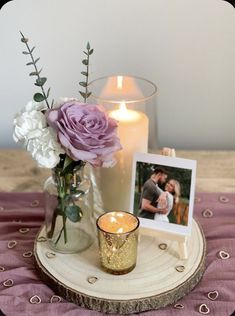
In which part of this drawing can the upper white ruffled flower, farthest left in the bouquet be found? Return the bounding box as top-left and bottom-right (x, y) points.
(13, 101), (47, 146)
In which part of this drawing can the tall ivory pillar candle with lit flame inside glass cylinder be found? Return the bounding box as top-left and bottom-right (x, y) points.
(95, 102), (148, 211)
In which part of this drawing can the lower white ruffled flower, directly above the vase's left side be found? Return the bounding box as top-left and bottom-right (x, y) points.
(27, 127), (64, 168)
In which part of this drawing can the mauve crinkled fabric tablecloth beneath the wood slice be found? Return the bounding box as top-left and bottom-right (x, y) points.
(0, 193), (235, 316)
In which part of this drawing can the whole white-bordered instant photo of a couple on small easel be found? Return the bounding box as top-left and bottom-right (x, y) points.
(130, 153), (196, 235)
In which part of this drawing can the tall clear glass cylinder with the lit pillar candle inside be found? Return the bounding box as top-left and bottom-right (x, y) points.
(89, 75), (157, 213)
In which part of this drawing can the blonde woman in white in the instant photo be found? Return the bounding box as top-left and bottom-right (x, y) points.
(154, 179), (180, 223)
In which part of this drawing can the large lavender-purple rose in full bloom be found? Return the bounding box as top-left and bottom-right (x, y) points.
(47, 100), (121, 166)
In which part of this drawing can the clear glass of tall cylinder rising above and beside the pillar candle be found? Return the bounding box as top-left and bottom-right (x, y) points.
(89, 75), (157, 148)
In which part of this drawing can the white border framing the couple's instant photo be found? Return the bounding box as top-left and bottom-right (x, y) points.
(130, 153), (197, 236)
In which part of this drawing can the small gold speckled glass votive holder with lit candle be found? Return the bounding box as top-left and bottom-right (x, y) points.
(96, 211), (140, 274)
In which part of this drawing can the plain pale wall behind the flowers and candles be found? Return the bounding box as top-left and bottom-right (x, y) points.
(0, 0), (235, 149)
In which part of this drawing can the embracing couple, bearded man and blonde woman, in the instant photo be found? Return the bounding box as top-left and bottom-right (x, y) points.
(139, 168), (180, 222)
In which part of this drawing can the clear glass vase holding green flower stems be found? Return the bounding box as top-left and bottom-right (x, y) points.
(44, 162), (95, 253)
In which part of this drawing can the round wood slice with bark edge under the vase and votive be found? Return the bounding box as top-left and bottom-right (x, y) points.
(34, 220), (206, 314)
